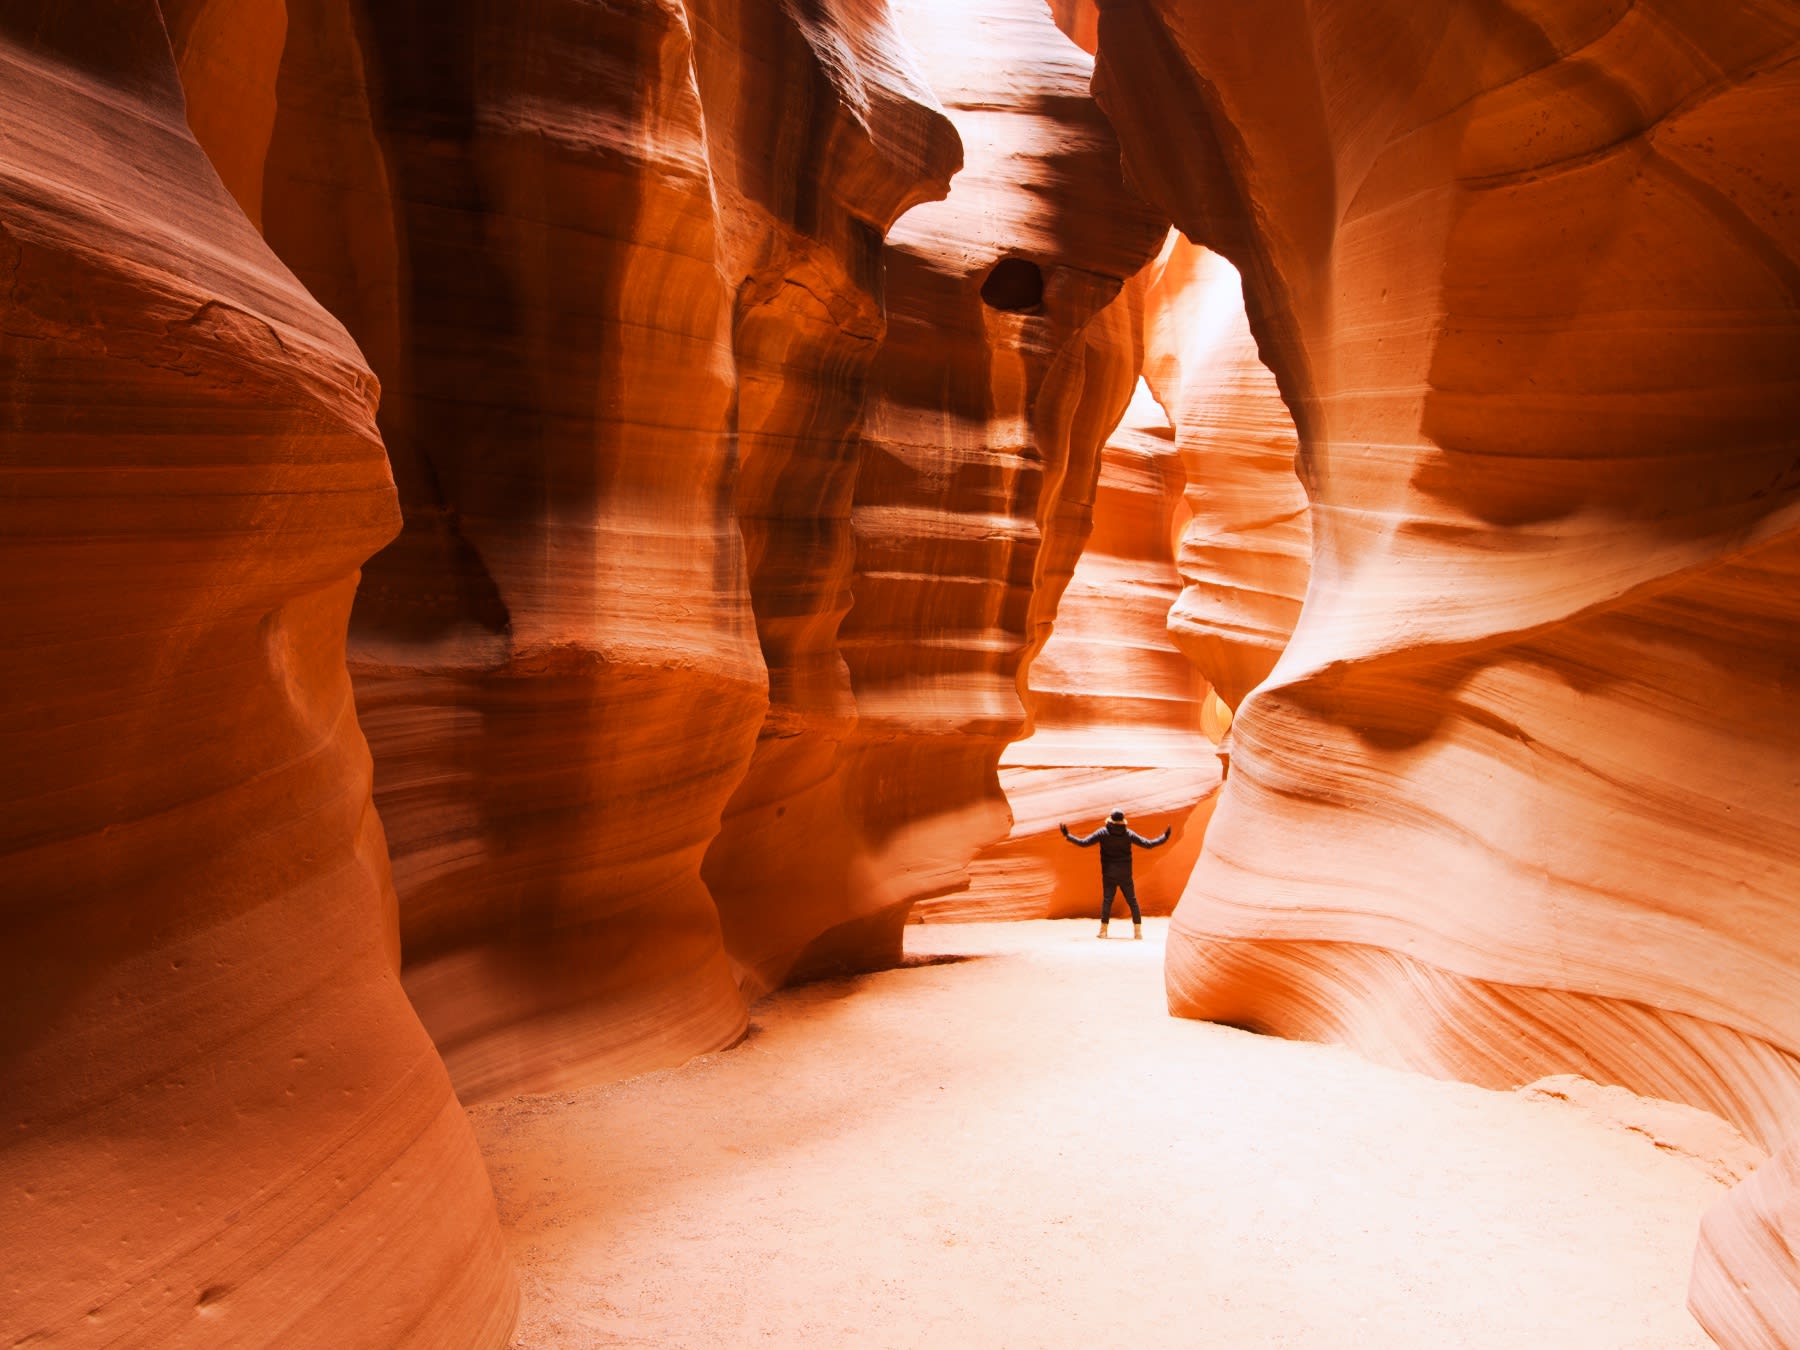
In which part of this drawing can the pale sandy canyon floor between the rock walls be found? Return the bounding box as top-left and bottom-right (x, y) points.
(472, 920), (1749, 1350)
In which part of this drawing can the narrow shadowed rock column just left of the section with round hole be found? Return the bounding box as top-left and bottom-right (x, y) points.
(698, 5), (961, 997)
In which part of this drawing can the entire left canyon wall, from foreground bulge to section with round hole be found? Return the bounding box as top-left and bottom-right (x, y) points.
(0, 10), (1166, 1345)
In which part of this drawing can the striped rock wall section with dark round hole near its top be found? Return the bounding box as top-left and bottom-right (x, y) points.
(814, 0), (1166, 963)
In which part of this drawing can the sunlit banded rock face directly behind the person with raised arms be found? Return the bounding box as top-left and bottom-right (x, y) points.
(914, 382), (1219, 922)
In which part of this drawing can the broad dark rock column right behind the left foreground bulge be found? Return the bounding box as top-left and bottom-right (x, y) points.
(265, 0), (767, 1100)
